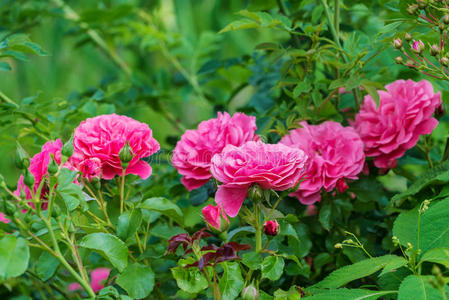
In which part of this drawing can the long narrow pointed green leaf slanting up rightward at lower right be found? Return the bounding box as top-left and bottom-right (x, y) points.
(313, 255), (404, 288)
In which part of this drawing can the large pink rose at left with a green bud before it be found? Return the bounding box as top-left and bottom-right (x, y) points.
(72, 114), (159, 179)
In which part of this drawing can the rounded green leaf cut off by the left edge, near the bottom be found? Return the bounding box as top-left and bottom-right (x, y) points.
(0, 235), (30, 280)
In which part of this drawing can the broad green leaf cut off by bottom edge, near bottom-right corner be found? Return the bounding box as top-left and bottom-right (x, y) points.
(398, 275), (448, 300)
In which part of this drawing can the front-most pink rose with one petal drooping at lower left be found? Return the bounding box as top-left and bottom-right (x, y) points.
(211, 141), (307, 217)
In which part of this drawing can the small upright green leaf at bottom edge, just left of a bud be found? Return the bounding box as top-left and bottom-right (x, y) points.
(218, 262), (244, 300)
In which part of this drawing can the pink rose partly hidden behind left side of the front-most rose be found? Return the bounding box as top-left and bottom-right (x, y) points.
(172, 112), (258, 191)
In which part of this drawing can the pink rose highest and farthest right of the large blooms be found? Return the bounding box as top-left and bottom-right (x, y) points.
(352, 80), (441, 169)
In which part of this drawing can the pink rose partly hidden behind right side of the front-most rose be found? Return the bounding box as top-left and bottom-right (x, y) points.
(280, 121), (365, 205)
